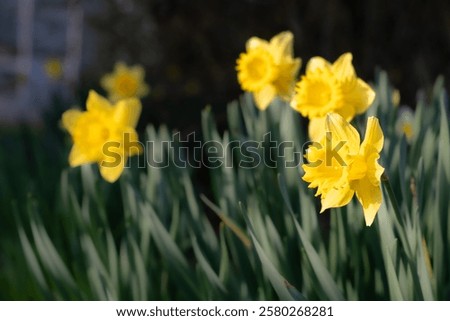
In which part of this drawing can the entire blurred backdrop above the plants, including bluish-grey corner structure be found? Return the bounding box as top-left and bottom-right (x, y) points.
(0, 0), (450, 131)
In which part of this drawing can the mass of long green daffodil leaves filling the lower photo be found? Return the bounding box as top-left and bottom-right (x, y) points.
(0, 73), (450, 300)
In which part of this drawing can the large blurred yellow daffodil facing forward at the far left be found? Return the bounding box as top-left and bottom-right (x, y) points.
(62, 90), (142, 183)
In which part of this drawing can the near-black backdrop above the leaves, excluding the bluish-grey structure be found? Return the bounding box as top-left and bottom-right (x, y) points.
(80, 0), (450, 131)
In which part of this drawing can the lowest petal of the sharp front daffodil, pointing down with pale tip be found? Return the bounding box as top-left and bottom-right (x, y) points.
(353, 179), (382, 226)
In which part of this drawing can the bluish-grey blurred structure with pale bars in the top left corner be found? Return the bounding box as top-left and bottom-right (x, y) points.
(0, 0), (90, 123)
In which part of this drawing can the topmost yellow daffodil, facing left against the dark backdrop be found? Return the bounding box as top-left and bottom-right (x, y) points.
(236, 31), (301, 110)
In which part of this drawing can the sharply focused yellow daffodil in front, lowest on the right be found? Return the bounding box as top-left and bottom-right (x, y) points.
(302, 113), (384, 226)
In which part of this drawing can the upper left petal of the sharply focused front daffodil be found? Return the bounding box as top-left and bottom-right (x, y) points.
(326, 113), (360, 154)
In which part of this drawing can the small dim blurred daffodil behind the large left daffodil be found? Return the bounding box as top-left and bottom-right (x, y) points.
(100, 62), (149, 102)
